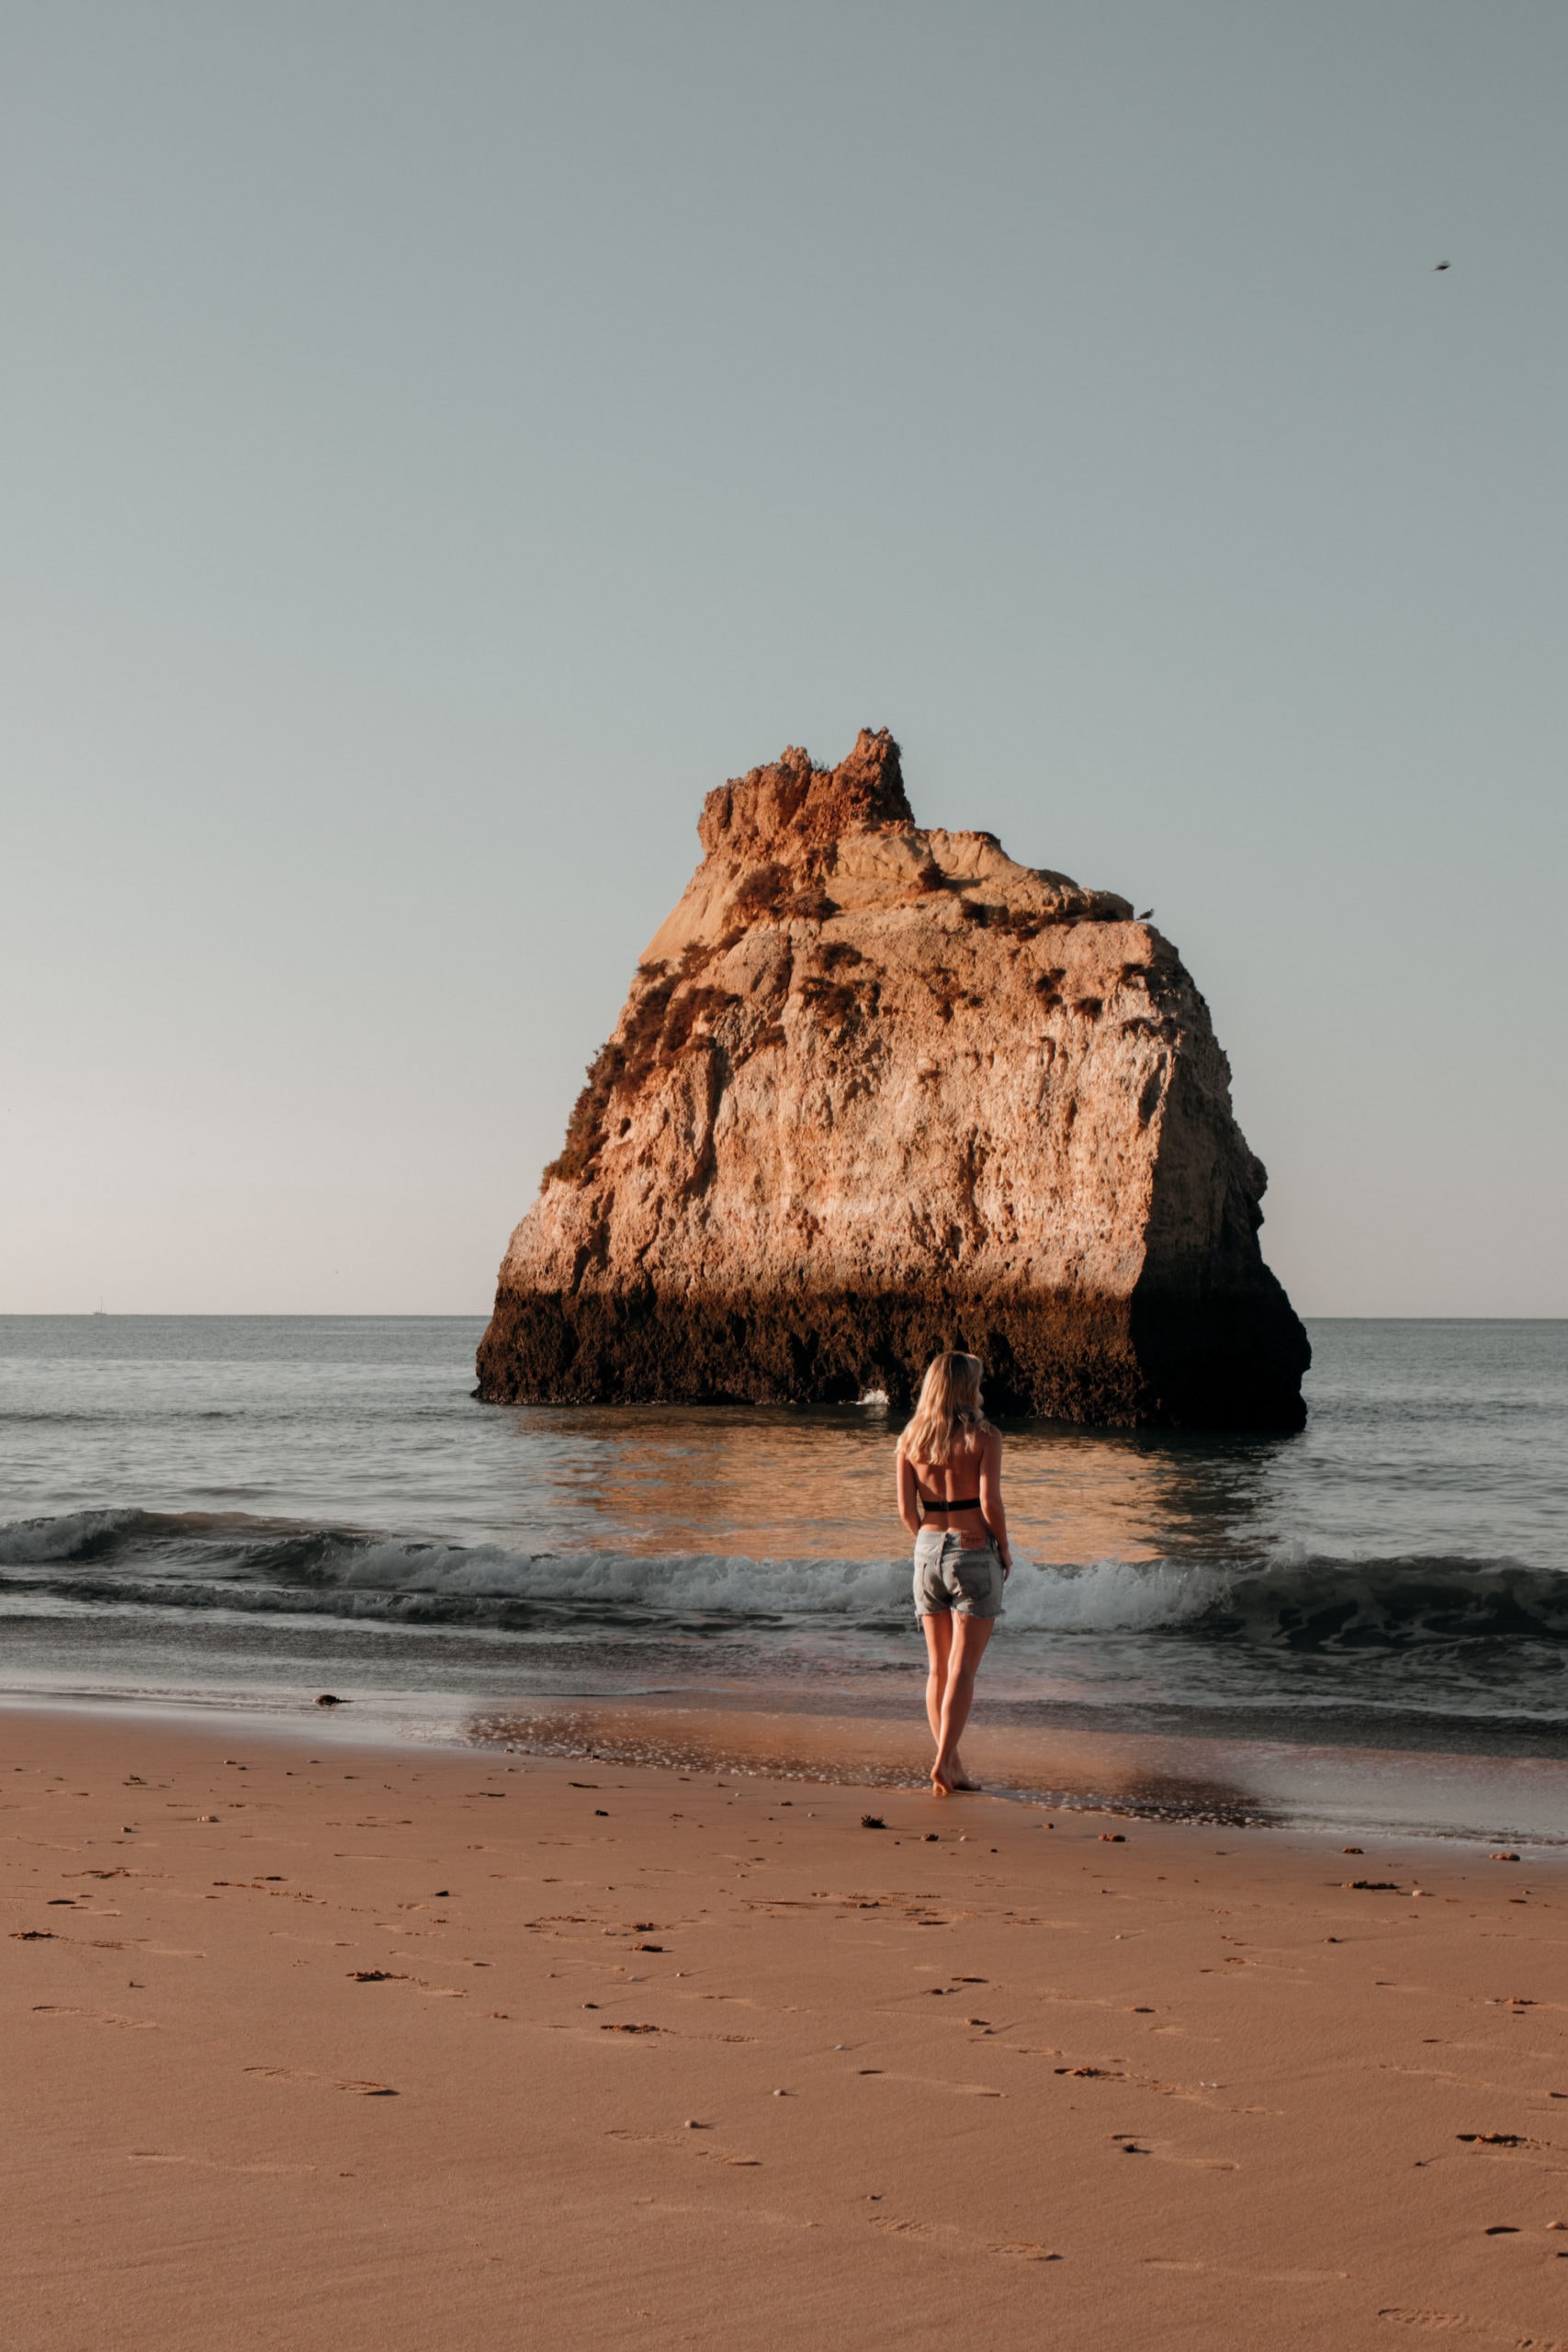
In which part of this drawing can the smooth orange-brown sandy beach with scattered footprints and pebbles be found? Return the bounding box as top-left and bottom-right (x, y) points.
(0, 1713), (1568, 2352)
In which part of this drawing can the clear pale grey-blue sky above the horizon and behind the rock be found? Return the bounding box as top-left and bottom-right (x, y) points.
(0, 0), (1568, 1315)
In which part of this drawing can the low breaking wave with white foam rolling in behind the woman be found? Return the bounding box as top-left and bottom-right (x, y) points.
(0, 1510), (1568, 1651)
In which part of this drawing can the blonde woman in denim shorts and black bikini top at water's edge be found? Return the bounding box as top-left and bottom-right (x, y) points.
(898, 1352), (1013, 1797)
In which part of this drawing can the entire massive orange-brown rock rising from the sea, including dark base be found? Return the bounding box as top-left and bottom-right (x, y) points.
(479, 731), (1309, 1428)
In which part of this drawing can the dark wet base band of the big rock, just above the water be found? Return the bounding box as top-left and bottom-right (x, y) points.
(478, 1268), (1312, 1430)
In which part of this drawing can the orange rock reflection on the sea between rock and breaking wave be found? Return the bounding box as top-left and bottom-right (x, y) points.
(514, 1407), (1291, 1564)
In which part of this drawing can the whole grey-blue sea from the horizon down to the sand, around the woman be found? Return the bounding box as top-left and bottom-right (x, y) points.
(0, 1315), (1568, 1849)
